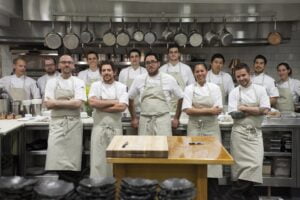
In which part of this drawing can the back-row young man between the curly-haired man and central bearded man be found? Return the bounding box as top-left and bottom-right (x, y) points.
(119, 49), (147, 112)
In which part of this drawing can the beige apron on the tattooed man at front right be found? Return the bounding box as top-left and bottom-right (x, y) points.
(230, 85), (264, 183)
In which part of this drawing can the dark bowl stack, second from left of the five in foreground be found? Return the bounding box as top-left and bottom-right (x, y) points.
(34, 180), (78, 200)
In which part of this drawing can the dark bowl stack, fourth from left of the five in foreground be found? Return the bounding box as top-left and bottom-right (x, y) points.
(120, 178), (158, 200)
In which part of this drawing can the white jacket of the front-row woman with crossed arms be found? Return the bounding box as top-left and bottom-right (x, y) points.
(182, 82), (223, 110)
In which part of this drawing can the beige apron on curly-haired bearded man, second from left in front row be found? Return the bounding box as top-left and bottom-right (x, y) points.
(90, 82), (123, 178)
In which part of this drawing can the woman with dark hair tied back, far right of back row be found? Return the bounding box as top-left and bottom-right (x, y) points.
(276, 63), (300, 112)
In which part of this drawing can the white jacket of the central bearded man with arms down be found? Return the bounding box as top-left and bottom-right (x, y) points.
(128, 72), (183, 102)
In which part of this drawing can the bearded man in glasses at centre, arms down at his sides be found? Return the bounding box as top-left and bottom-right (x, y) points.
(128, 53), (183, 136)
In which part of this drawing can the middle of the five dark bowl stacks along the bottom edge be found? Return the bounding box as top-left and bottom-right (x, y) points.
(76, 177), (116, 200)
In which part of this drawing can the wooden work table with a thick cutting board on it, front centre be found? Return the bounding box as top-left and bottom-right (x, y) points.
(107, 136), (234, 200)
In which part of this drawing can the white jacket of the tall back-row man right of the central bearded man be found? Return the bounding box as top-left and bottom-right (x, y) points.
(159, 62), (195, 86)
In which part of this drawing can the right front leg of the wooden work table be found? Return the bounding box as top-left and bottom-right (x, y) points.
(196, 165), (207, 200)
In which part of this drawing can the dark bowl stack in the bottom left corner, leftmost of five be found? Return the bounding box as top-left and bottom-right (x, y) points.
(0, 176), (37, 200)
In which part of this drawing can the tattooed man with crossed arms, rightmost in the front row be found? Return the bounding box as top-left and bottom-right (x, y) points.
(225, 63), (270, 200)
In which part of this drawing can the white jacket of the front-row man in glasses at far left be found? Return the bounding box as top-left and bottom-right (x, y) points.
(45, 76), (87, 101)
